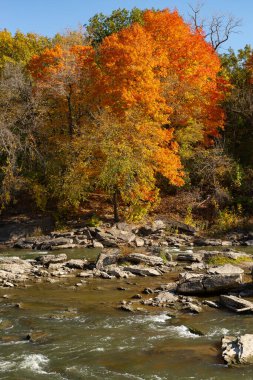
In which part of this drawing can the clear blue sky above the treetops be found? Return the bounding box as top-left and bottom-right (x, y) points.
(0, 0), (253, 50)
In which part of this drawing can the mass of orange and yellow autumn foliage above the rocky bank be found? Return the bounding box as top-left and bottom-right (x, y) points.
(0, 9), (226, 220)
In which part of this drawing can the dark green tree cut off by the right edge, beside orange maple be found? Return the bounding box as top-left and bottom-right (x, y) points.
(222, 46), (253, 166)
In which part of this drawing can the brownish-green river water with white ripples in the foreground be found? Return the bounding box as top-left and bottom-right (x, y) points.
(0, 246), (253, 380)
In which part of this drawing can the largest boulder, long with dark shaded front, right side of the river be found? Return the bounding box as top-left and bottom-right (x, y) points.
(177, 273), (242, 294)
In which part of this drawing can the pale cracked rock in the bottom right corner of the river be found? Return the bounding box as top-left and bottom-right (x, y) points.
(222, 334), (253, 365)
